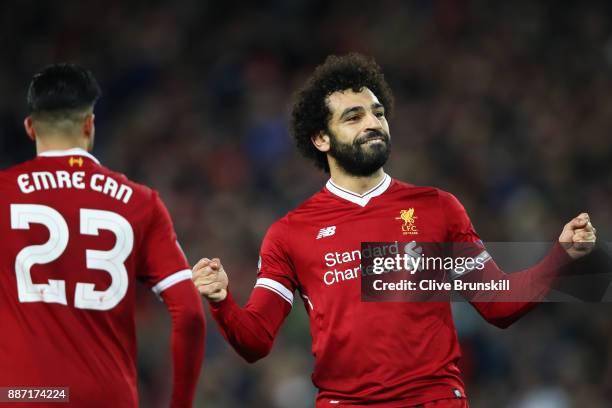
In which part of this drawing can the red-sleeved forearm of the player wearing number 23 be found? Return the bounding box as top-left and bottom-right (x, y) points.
(162, 282), (205, 408)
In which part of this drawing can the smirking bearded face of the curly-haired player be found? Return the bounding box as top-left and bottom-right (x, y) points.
(327, 88), (391, 176)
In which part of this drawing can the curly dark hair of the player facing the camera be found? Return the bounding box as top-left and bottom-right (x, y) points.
(291, 53), (393, 173)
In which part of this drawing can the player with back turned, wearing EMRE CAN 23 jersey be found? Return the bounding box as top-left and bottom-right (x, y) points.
(0, 64), (205, 408)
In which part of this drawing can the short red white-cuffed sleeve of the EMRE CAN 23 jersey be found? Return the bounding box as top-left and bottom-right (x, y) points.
(138, 192), (191, 295)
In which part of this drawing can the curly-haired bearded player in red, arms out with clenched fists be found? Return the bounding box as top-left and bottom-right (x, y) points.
(193, 54), (595, 408)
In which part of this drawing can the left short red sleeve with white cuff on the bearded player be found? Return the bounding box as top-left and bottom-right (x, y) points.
(255, 218), (297, 304)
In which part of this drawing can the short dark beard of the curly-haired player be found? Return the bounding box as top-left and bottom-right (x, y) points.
(328, 130), (391, 177)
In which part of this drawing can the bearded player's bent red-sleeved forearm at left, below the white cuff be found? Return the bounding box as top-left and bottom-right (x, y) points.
(210, 288), (291, 363)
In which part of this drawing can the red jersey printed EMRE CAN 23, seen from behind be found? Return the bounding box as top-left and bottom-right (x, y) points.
(0, 149), (191, 408)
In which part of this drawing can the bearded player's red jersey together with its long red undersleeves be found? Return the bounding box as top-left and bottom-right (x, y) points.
(210, 175), (571, 408)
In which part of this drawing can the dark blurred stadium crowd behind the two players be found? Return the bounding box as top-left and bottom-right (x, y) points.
(0, 0), (612, 408)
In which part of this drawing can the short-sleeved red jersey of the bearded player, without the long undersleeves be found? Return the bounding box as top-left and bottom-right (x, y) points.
(256, 175), (479, 407)
